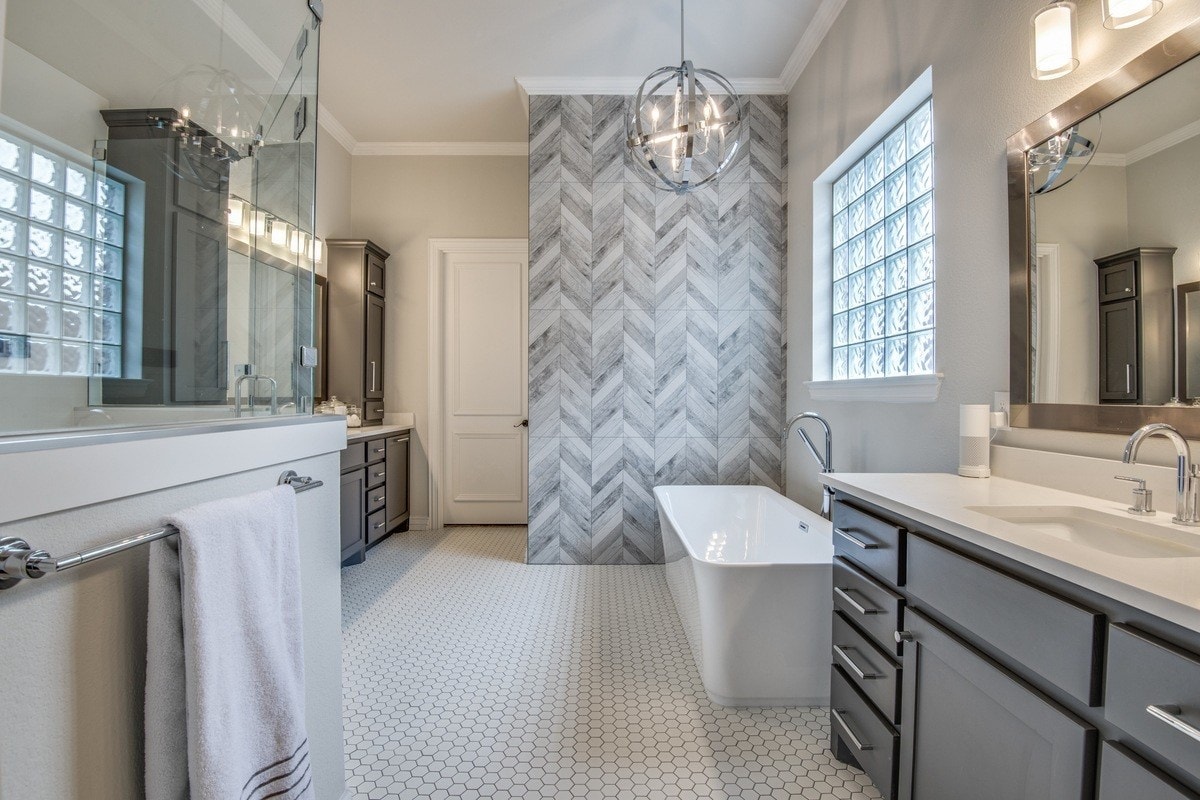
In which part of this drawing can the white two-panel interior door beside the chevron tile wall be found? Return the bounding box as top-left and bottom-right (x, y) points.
(442, 248), (529, 525)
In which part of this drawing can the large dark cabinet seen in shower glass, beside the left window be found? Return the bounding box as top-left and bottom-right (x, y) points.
(101, 108), (229, 405)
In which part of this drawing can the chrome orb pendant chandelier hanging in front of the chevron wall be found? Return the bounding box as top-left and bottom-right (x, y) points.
(626, 0), (744, 194)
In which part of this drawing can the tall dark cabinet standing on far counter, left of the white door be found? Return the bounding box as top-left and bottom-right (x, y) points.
(323, 239), (388, 425)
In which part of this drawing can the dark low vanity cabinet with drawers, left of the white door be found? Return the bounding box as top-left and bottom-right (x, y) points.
(342, 431), (410, 566)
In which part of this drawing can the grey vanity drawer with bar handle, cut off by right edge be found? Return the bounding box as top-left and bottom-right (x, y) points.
(1104, 625), (1200, 778)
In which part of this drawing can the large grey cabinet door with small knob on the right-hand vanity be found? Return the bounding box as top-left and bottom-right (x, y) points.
(899, 610), (1097, 800)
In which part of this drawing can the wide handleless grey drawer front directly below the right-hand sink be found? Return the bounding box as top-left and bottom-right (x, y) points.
(908, 535), (1099, 705)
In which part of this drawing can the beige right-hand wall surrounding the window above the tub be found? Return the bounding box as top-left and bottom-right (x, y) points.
(787, 0), (1200, 513)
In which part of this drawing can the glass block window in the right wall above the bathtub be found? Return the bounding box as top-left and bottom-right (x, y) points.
(833, 100), (934, 380)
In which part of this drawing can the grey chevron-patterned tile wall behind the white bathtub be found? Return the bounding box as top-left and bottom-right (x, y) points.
(528, 95), (787, 564)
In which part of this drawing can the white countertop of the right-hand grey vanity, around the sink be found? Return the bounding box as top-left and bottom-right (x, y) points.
(821, 473), (1200, 632)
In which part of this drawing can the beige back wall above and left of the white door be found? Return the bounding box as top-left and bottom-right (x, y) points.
(350, 156), (529, 518)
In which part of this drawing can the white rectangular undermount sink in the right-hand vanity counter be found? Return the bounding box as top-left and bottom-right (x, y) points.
(967, 505), (1200, 559)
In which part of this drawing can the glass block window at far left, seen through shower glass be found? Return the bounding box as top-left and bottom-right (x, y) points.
(0, 130), (125, 378)
